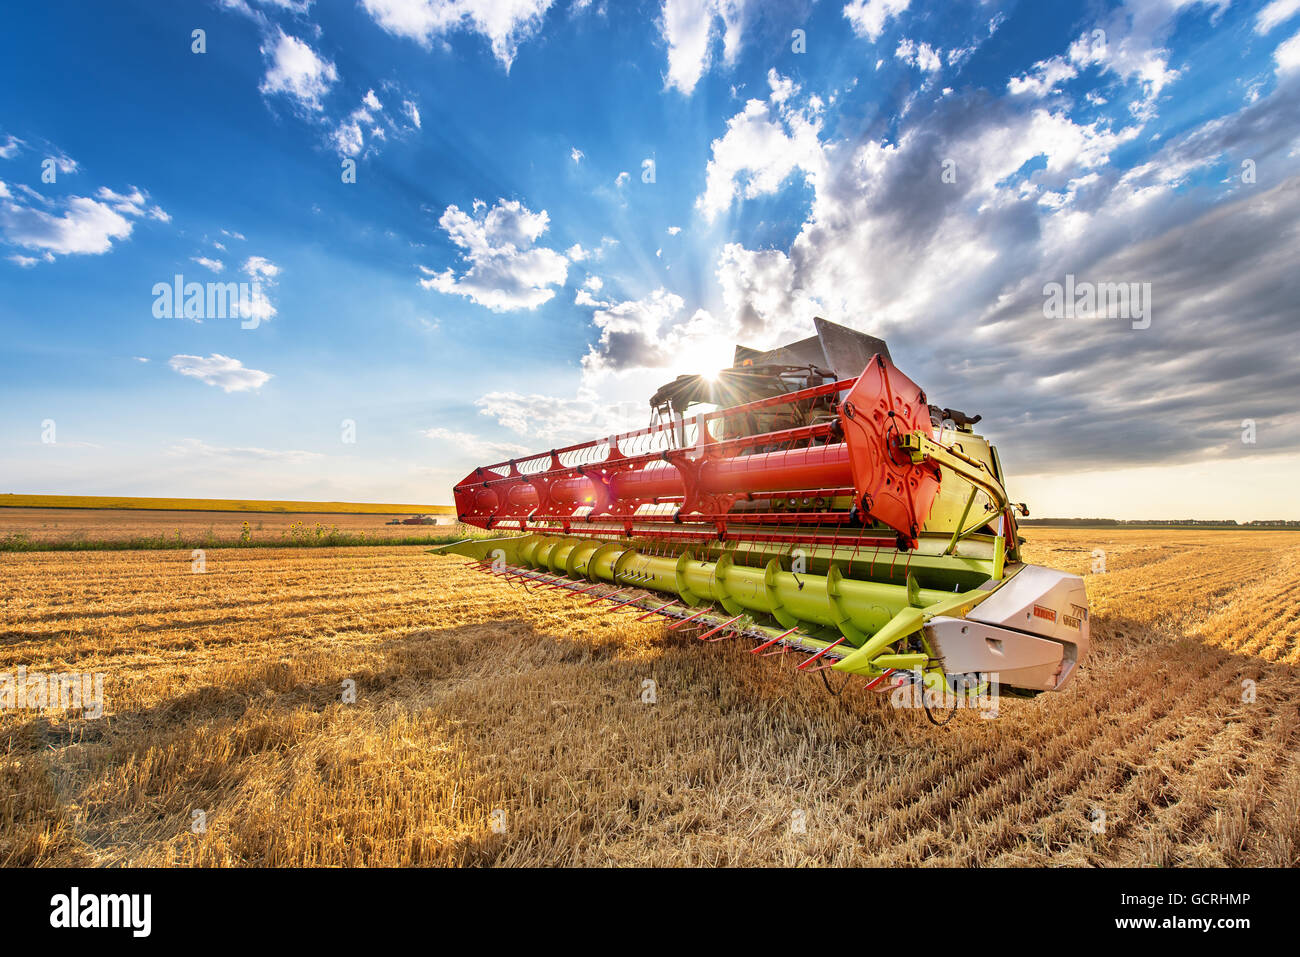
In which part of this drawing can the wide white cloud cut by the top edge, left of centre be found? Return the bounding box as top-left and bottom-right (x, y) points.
(361, 0), (553, 70)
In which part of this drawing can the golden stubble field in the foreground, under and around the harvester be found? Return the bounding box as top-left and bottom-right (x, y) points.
(0, 528), (1300, 866)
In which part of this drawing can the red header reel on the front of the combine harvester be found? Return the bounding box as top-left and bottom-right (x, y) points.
(455, 355), (939, 545)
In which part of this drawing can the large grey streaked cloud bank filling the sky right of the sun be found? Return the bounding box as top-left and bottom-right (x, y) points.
(720, 66), (1300, 473)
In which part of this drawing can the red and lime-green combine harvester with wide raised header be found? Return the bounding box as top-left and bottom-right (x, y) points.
(438, 319), (1088, 720)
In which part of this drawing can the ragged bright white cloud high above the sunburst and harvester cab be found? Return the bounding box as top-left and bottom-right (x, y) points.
(696, 70), (826, 221)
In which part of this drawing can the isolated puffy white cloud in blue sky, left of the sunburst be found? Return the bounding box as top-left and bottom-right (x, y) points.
(420, 199), (568, 312)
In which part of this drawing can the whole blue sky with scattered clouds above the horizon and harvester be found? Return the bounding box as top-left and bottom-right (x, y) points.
(0, 0), (1300, 519)
